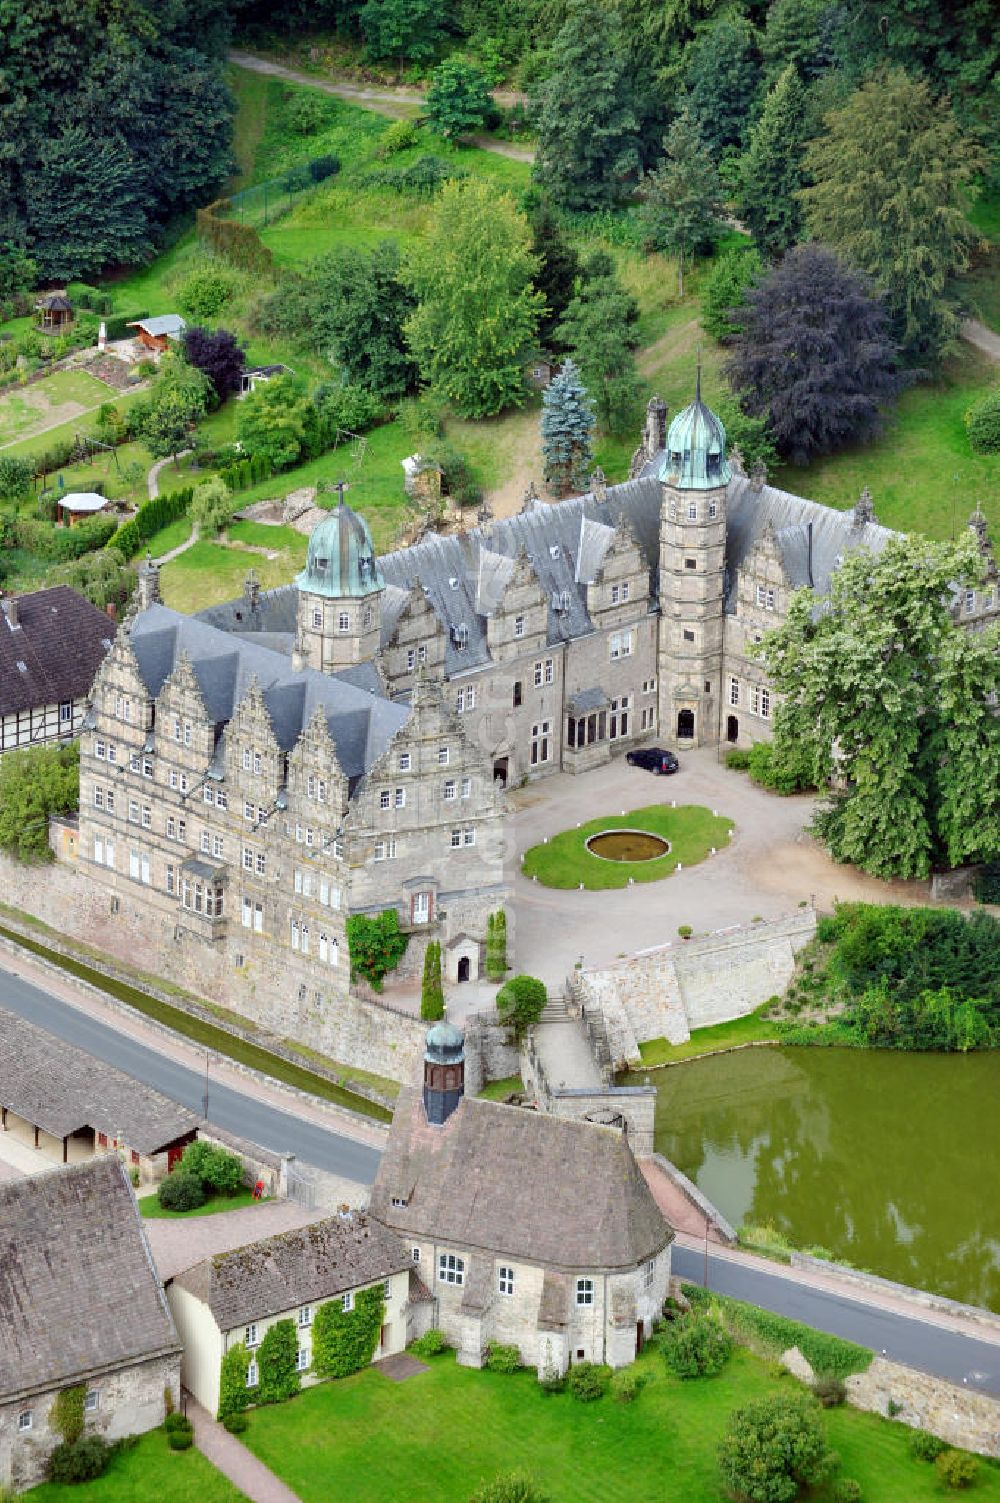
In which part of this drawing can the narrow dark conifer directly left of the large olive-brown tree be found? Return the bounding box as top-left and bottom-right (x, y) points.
(738, 63), (806, 260)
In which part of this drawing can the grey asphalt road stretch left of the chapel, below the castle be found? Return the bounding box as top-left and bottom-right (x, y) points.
(0, 966), (380, 1184)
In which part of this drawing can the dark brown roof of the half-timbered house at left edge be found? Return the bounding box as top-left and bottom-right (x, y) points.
(0, 585), (114, 715)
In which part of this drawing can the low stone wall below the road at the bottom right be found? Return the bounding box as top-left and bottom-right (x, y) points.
(847, 1357), (1000, 1456)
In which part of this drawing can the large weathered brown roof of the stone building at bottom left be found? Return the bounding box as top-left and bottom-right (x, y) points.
(0, 1157), (180, 1404)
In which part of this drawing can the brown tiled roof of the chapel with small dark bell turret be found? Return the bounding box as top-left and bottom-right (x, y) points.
(370, 1087), (674, 1270)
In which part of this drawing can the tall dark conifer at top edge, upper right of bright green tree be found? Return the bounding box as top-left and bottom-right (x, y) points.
(534, 0), (639, 210)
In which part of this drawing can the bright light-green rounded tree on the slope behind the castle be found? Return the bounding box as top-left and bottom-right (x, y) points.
(405, 179), (543, 418)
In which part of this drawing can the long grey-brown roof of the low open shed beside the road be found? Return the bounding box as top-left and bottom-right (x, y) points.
(0, 1007), (198, 1153)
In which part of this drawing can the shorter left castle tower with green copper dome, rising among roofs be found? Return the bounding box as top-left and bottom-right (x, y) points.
(295, 494), (385, 673)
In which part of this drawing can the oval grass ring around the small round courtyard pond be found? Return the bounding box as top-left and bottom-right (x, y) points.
(522, 804), (732, 891)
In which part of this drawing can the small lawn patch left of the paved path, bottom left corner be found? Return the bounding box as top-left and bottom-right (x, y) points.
(24, 1429), (248, 1503)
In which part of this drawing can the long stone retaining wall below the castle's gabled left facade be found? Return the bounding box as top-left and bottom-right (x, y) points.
(0, 855), (426, 1084)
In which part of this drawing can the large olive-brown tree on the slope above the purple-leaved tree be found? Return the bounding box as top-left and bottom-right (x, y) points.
(802, 69), (983, 364)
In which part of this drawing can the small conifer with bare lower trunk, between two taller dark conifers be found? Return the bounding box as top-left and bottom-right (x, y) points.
(641, 110), (723, 298)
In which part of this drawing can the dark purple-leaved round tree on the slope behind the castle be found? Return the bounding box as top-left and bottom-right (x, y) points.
(725, 245), (901, 464)
